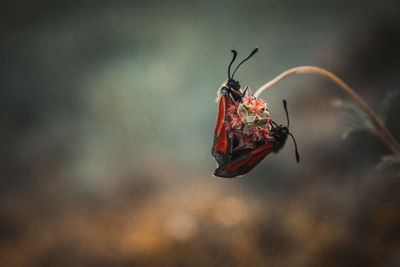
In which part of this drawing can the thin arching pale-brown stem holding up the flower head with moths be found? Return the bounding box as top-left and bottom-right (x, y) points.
(254, 66), (400, 161)
